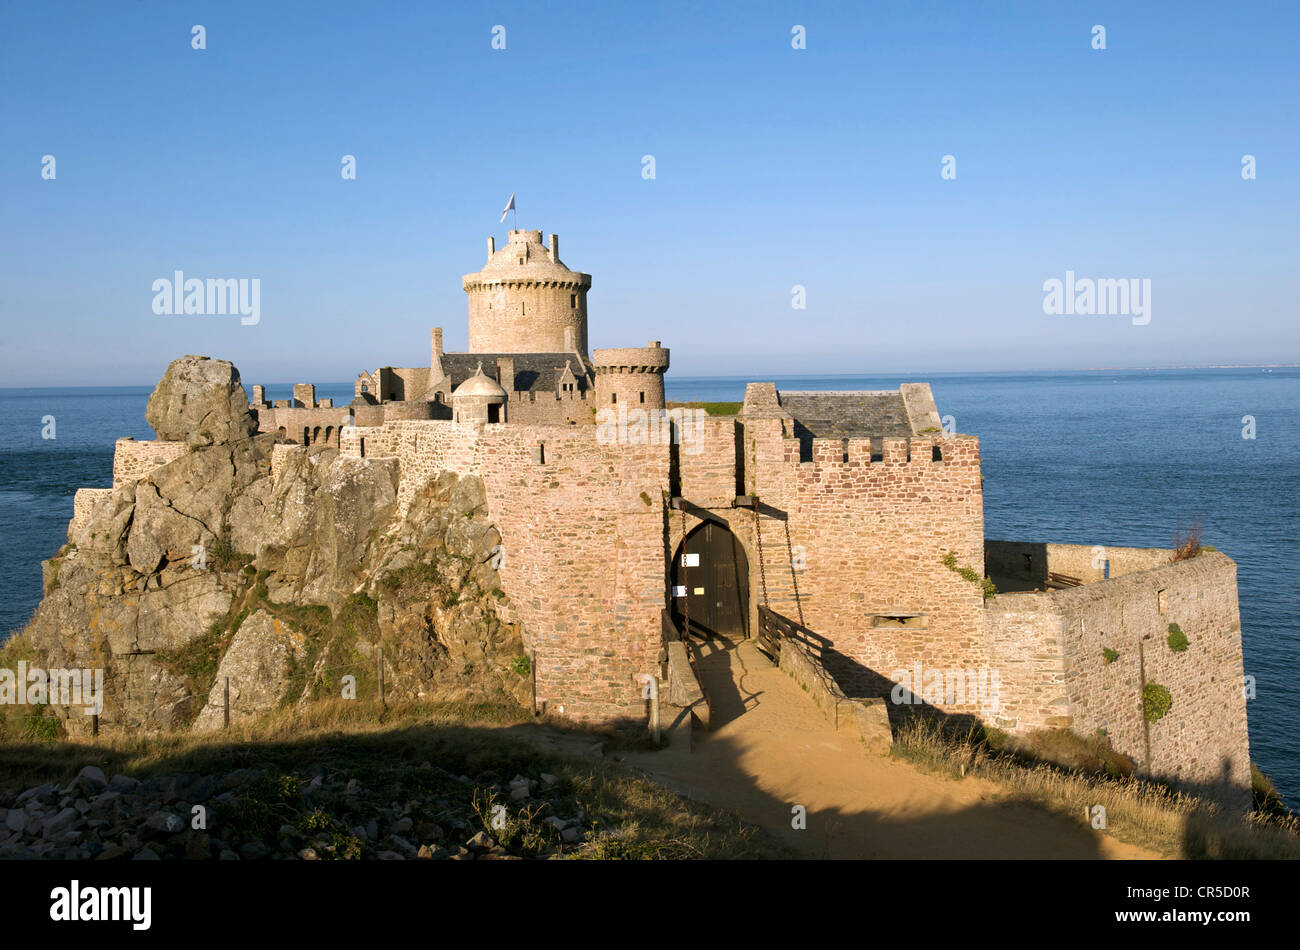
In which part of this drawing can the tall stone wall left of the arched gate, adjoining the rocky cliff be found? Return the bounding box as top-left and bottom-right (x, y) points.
(341, 421), (670, 719)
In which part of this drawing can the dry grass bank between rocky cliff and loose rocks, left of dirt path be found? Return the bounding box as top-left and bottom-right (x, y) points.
(0, 699), (788, 859)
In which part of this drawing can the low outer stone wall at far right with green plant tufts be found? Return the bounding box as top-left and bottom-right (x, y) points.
(988, 552), (1251, 794)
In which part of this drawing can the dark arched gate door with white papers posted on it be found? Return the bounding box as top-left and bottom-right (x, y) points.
(670, 521), (749, 639)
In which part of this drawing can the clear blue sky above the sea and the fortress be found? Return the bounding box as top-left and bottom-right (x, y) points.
(0, 0), (1300, 386)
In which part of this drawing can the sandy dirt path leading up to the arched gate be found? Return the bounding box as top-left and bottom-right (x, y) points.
(624, 641), (1161, 859)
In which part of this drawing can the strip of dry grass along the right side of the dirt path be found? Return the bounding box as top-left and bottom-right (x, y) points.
(894, 719), (1300, 859)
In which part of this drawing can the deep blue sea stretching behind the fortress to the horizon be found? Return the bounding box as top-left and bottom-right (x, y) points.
(0, 368), (1300, 807)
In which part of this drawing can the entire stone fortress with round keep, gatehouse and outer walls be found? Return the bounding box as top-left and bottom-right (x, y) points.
(98, 230), (1251, 801)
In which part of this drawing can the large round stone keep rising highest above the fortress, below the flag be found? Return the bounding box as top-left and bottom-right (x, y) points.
(462, 231), (592, 355)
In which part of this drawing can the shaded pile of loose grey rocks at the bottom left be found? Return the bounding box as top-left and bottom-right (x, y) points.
(0, 763), (594, 860)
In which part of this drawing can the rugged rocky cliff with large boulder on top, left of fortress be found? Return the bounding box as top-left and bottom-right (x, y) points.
(26, 356), (528, 733)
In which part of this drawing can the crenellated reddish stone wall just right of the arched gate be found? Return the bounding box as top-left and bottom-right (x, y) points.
(742, 418), (988, 712)
